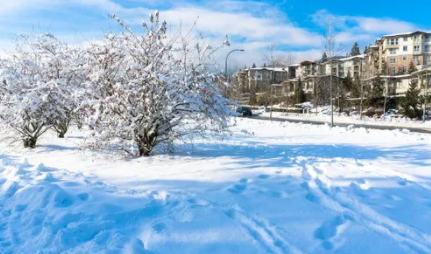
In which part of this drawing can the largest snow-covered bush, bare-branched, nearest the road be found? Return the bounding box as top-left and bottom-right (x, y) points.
(86, 13), (231, 156)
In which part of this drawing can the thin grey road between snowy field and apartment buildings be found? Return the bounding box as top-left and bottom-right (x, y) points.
(251, 115), (431, 134)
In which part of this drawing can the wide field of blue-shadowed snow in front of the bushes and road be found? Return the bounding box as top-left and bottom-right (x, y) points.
(0, 119), (431, 254)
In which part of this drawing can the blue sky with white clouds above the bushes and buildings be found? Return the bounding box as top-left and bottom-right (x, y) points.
(0, 0), (431, 66)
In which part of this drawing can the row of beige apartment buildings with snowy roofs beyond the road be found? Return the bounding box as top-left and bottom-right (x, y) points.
(236, 31), (431, 106)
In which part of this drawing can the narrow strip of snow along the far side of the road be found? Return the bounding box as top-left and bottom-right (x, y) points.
(256, 112), (431, 131)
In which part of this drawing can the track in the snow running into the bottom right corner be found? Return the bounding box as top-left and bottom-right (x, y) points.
(299, 161), (431, 253)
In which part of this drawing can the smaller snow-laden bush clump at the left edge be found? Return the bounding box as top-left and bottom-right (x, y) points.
(0, 34), (82, 148)
